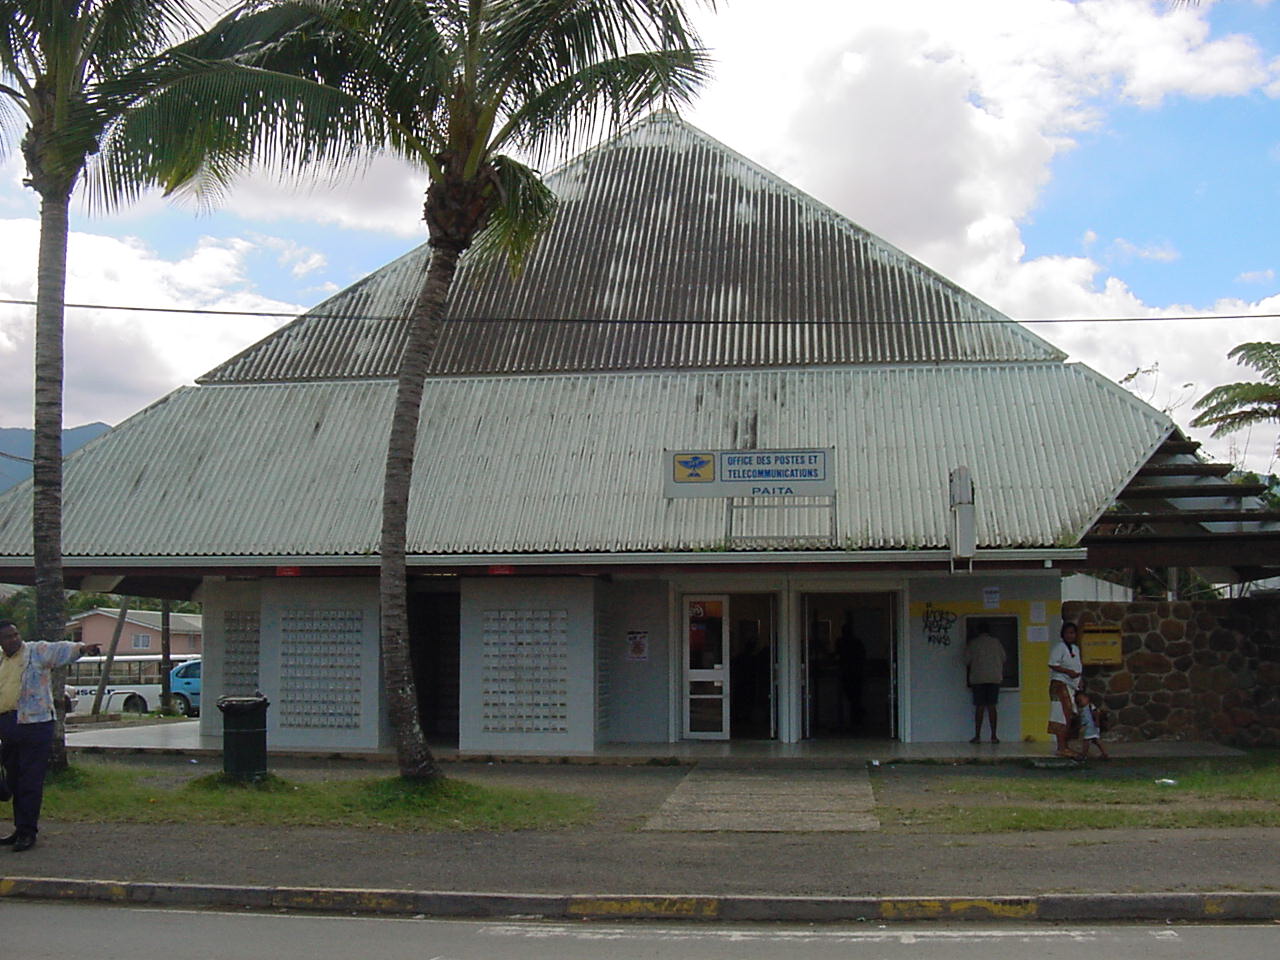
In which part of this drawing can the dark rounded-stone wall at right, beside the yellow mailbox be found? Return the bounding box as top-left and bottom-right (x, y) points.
(1062, 599), (1280, 746)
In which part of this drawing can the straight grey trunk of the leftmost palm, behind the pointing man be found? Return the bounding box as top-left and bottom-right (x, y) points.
(31, 189), (70, 769)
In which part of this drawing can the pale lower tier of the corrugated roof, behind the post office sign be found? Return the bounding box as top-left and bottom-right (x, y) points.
(0, 364), (1172, 559)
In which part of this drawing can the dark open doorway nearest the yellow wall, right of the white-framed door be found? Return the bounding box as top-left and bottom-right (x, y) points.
(804, 593), (897, 739)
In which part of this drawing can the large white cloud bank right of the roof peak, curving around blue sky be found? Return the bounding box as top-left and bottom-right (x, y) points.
(690, 0), (1280, 468)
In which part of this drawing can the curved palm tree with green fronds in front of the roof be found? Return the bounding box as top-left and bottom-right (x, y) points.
(204, 0), (712, 780)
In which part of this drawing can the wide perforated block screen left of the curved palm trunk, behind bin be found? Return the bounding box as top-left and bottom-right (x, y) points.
(280, 607), (365, 727)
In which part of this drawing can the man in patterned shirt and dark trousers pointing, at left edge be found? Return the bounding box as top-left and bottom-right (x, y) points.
(0, 620), (92, 852)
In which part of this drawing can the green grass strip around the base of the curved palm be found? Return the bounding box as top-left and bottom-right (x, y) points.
(44, 763), (595, 831)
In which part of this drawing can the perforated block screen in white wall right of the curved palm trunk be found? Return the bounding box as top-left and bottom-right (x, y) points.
(480, 609), (568, 733)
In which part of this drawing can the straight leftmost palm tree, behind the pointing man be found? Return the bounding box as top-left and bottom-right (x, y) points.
(0, 0), (366, 756)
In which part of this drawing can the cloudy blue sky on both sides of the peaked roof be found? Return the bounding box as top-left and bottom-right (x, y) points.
(0, 0), (1280, 472)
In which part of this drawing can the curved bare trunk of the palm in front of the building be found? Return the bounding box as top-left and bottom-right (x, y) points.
(379, 246), (458, 780)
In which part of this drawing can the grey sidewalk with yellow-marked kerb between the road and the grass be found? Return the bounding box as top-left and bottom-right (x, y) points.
(0, 755), (1280, 920)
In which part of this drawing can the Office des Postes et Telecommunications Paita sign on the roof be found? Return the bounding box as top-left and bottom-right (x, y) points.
(662, 447), (836, 498)
